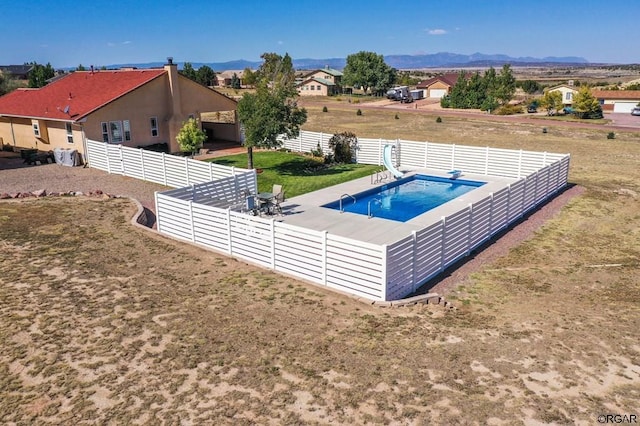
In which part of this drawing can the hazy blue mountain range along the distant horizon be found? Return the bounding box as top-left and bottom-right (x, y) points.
(107, 52), (589, 72)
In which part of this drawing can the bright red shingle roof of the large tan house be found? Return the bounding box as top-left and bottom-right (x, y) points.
(0, 69), (166, 121)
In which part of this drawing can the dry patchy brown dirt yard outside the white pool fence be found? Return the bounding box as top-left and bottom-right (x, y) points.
(0, 112), (640, 425)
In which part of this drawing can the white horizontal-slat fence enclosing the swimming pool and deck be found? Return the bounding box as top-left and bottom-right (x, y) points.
(156, 132), (569, 300)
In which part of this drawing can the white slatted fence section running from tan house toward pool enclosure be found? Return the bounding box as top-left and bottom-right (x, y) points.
(86, 140), (255, 188)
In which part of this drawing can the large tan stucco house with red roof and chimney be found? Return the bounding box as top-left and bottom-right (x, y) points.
(0, 59), (240, 159)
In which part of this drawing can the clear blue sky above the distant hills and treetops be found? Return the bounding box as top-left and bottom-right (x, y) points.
(0, 0), (640, 68)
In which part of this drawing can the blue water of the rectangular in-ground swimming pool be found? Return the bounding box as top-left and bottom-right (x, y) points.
(322, 175), (486, 222)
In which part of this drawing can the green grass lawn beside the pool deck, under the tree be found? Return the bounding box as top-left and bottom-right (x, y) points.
(209, 151), (380, 197)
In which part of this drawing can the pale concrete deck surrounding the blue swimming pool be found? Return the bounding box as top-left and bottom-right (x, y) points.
(274, 169), (517, 245)
